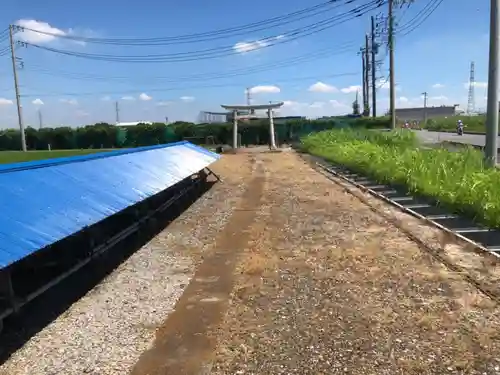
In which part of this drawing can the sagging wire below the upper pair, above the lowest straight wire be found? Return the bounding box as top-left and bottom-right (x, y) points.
(21, 42), (356, 83)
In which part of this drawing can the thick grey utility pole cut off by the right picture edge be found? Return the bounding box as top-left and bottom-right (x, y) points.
(484, 0), (500, 167)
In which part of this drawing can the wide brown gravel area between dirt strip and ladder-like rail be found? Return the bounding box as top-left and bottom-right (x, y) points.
(212, 153), (500, 375)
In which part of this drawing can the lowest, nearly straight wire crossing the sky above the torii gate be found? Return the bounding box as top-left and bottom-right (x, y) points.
(22, 72), (360, 97)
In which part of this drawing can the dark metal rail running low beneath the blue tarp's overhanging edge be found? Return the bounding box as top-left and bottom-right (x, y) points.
(0, 168), (214, 332)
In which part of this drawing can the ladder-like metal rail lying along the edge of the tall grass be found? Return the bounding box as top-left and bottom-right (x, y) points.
(316, 162), (500, 258)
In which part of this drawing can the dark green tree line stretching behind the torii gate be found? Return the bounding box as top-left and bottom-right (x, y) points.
(0, 117), (389, 151)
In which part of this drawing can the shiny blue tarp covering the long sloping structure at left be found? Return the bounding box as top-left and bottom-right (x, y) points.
(0, 142), (219, 269)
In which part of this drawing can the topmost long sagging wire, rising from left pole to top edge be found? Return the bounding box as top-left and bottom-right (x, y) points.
(21, 0), (359, 46)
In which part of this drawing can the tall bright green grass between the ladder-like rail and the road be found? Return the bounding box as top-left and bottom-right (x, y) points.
(303, 130), (500, 227)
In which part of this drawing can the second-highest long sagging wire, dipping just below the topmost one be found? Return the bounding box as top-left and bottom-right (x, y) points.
(28, 0), (386, 63)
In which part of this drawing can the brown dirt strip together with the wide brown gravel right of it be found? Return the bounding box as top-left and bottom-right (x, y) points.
(133, 153), (500, 375)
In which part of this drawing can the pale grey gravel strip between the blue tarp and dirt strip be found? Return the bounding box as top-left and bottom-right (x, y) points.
(0, 162), (250, 375)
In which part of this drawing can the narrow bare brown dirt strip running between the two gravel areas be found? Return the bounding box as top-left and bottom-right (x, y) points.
(131, 155), (264, 375)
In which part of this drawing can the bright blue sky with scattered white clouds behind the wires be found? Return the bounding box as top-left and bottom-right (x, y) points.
(0, 0), (489, 128)
